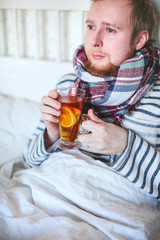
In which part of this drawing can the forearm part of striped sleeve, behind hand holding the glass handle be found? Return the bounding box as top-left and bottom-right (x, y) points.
(111, 130), (160, 199)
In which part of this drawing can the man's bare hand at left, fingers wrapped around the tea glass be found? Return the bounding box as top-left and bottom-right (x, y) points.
(40, 90), (61, 148)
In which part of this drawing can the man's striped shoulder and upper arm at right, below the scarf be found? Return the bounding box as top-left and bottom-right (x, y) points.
(123, 79), (160, 147)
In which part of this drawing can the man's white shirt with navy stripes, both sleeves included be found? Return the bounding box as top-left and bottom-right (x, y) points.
(23, 74), (160, 199)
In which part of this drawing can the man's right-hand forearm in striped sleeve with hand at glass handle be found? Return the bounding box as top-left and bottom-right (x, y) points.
(79, 110), (160, 199)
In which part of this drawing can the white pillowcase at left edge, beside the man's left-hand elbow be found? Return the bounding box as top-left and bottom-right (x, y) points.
(0, 94), (41, 163)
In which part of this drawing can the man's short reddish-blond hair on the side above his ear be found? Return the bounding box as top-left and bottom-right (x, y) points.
(91, 0), (155, 43)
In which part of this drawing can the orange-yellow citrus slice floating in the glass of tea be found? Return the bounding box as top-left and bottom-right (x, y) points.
(59, 106), (77, 127)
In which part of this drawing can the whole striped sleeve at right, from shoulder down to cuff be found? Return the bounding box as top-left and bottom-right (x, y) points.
(111, 79), (160, 199)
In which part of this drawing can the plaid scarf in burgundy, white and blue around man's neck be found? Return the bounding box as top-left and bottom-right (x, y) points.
(73, 43), (160, 125)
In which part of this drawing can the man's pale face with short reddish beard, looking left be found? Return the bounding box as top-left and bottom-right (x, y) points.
(84, 0), (135, 75)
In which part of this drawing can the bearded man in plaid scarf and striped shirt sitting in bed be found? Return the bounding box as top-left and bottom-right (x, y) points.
(24, 0), (160, 198)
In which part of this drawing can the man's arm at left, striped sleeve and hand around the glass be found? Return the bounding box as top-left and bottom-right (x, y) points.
(23, 90), (61, 167)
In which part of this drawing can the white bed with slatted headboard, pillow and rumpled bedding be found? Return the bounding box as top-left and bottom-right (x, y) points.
(0, 0), (160, 240)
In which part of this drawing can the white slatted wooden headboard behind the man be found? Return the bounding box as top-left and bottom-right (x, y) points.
(0, 0), (160, 101)
